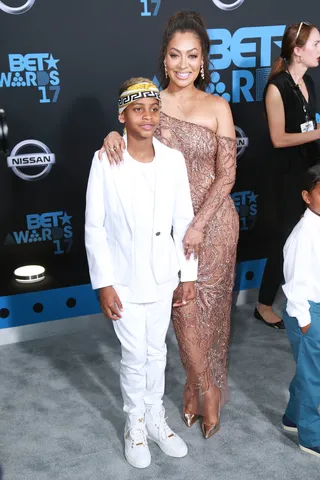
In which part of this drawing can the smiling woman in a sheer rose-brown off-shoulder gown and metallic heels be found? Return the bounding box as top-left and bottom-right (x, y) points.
(101, 12), (239, 438)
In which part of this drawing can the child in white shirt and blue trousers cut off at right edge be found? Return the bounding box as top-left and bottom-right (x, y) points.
(282, 165), (320, 457)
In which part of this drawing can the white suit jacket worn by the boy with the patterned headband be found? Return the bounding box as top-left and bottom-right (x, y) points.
(85, 138), (197, 289)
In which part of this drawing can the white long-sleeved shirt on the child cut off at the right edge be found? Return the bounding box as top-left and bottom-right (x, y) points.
(282, 208), (320, 327)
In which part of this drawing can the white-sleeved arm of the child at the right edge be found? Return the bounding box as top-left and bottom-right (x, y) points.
(282, 235), (312, 328)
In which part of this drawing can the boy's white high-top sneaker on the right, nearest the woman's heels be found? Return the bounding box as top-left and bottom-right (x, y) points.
(146, 407), (188, 458)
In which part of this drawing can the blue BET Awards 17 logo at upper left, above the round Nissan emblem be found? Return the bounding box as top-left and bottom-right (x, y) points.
(0, 53), (60, 103)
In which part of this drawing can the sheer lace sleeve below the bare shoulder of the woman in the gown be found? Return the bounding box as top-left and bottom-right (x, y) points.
(191, 135), (236, 230)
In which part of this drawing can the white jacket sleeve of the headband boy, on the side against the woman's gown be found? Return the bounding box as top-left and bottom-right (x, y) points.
(172, 152), (198, 282)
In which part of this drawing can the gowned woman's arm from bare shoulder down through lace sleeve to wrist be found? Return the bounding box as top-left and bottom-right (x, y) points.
(191, 98), (236, 231)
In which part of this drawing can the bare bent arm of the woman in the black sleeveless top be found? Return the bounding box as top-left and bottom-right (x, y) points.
(266, 85), (320, 148)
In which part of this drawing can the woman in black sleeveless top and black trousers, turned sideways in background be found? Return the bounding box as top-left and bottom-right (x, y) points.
(254, 22), (320, 329)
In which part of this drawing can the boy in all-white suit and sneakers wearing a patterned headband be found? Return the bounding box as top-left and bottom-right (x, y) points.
(85, 78), (197, 468)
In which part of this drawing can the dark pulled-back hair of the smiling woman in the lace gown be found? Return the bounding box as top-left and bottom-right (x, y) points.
(159, 11), (211, 91)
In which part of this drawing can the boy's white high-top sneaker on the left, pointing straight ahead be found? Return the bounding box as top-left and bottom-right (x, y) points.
(124, 418), (151, 468)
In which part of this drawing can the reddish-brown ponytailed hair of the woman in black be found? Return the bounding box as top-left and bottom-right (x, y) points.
(269, 22), (317, 80)
